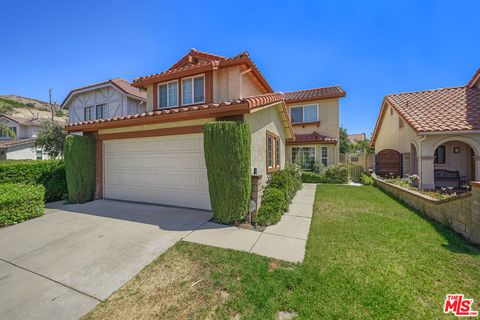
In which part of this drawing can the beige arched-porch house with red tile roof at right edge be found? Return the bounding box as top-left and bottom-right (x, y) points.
(371, 69), (480, 189)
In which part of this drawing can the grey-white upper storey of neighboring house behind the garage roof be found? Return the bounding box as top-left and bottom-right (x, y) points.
(62, 78), (147, 123)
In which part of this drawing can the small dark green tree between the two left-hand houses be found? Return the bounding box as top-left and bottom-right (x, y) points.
(35, 119), (67, 158)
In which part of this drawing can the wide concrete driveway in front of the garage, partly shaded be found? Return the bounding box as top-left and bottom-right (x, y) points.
(0, 200), (211, 319)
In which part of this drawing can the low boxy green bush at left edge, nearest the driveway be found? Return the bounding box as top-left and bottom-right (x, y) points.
(0, 183), (45, 227)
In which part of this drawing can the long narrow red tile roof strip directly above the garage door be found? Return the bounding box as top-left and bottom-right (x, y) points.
(65, 93), (288, 131)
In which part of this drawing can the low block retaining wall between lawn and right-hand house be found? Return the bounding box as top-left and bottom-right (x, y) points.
(374, 178), (480, 244)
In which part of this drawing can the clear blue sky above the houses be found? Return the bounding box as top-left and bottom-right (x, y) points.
(0, 0), (480, 134)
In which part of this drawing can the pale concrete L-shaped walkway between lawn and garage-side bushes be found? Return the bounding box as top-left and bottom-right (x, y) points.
(183, 183), (317, 262)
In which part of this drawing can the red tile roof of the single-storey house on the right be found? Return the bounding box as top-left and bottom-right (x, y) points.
(371, 86), (480, 145)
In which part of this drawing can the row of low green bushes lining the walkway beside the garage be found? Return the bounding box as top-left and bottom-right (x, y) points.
(254, 164), (302, 226)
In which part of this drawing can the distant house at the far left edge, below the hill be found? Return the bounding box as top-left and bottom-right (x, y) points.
(0, 115), (46, 160)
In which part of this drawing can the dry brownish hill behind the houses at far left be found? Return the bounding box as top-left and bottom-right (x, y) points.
(0, 94), (68, 122)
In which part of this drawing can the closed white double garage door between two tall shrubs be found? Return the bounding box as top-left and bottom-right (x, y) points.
(104, 134), (211, 210)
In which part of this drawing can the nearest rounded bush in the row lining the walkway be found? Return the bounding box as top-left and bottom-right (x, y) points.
(254, 188), (288, 226)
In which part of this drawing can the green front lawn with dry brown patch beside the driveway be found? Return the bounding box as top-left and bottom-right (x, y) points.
(86, 185), (480, 319)
